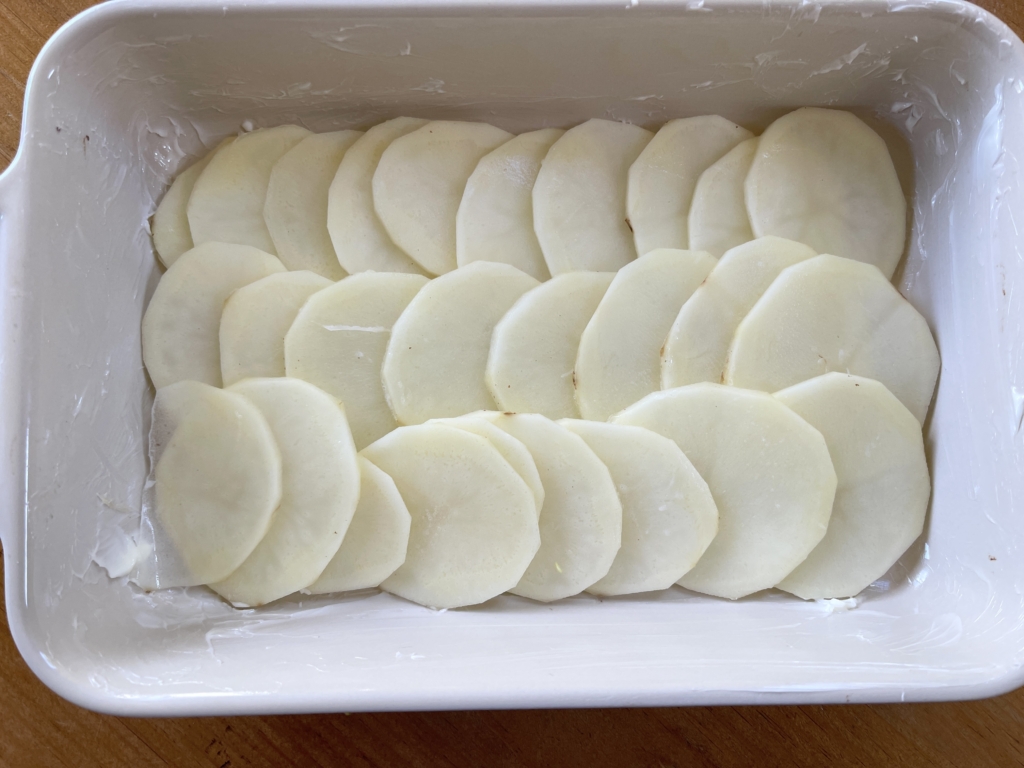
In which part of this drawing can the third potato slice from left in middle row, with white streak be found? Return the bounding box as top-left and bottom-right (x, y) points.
(285, 272), (427, 449)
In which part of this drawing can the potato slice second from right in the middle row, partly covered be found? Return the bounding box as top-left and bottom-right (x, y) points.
(662, 236), (817, 389)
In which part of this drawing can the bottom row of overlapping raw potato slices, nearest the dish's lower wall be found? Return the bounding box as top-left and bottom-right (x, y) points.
(154, 373), (930, 608)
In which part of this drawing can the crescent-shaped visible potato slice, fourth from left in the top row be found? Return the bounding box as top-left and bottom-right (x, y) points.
(327, 118), (428, 274)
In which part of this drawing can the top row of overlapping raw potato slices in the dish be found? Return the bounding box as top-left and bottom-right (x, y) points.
(153, 109), (906, 280)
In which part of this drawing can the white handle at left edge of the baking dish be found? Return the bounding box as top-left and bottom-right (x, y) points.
(0, 153), (25, 558)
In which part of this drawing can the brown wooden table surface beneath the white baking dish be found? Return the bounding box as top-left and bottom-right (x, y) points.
(0, 0), (1024, 768)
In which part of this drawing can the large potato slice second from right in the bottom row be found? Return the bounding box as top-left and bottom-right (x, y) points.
(615, 384), (836, 599)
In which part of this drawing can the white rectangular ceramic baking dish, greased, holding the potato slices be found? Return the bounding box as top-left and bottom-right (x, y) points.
(0, 0), (1024, 715)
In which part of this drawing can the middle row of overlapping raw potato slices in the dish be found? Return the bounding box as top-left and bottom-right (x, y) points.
(142, 237), (939, 449)
